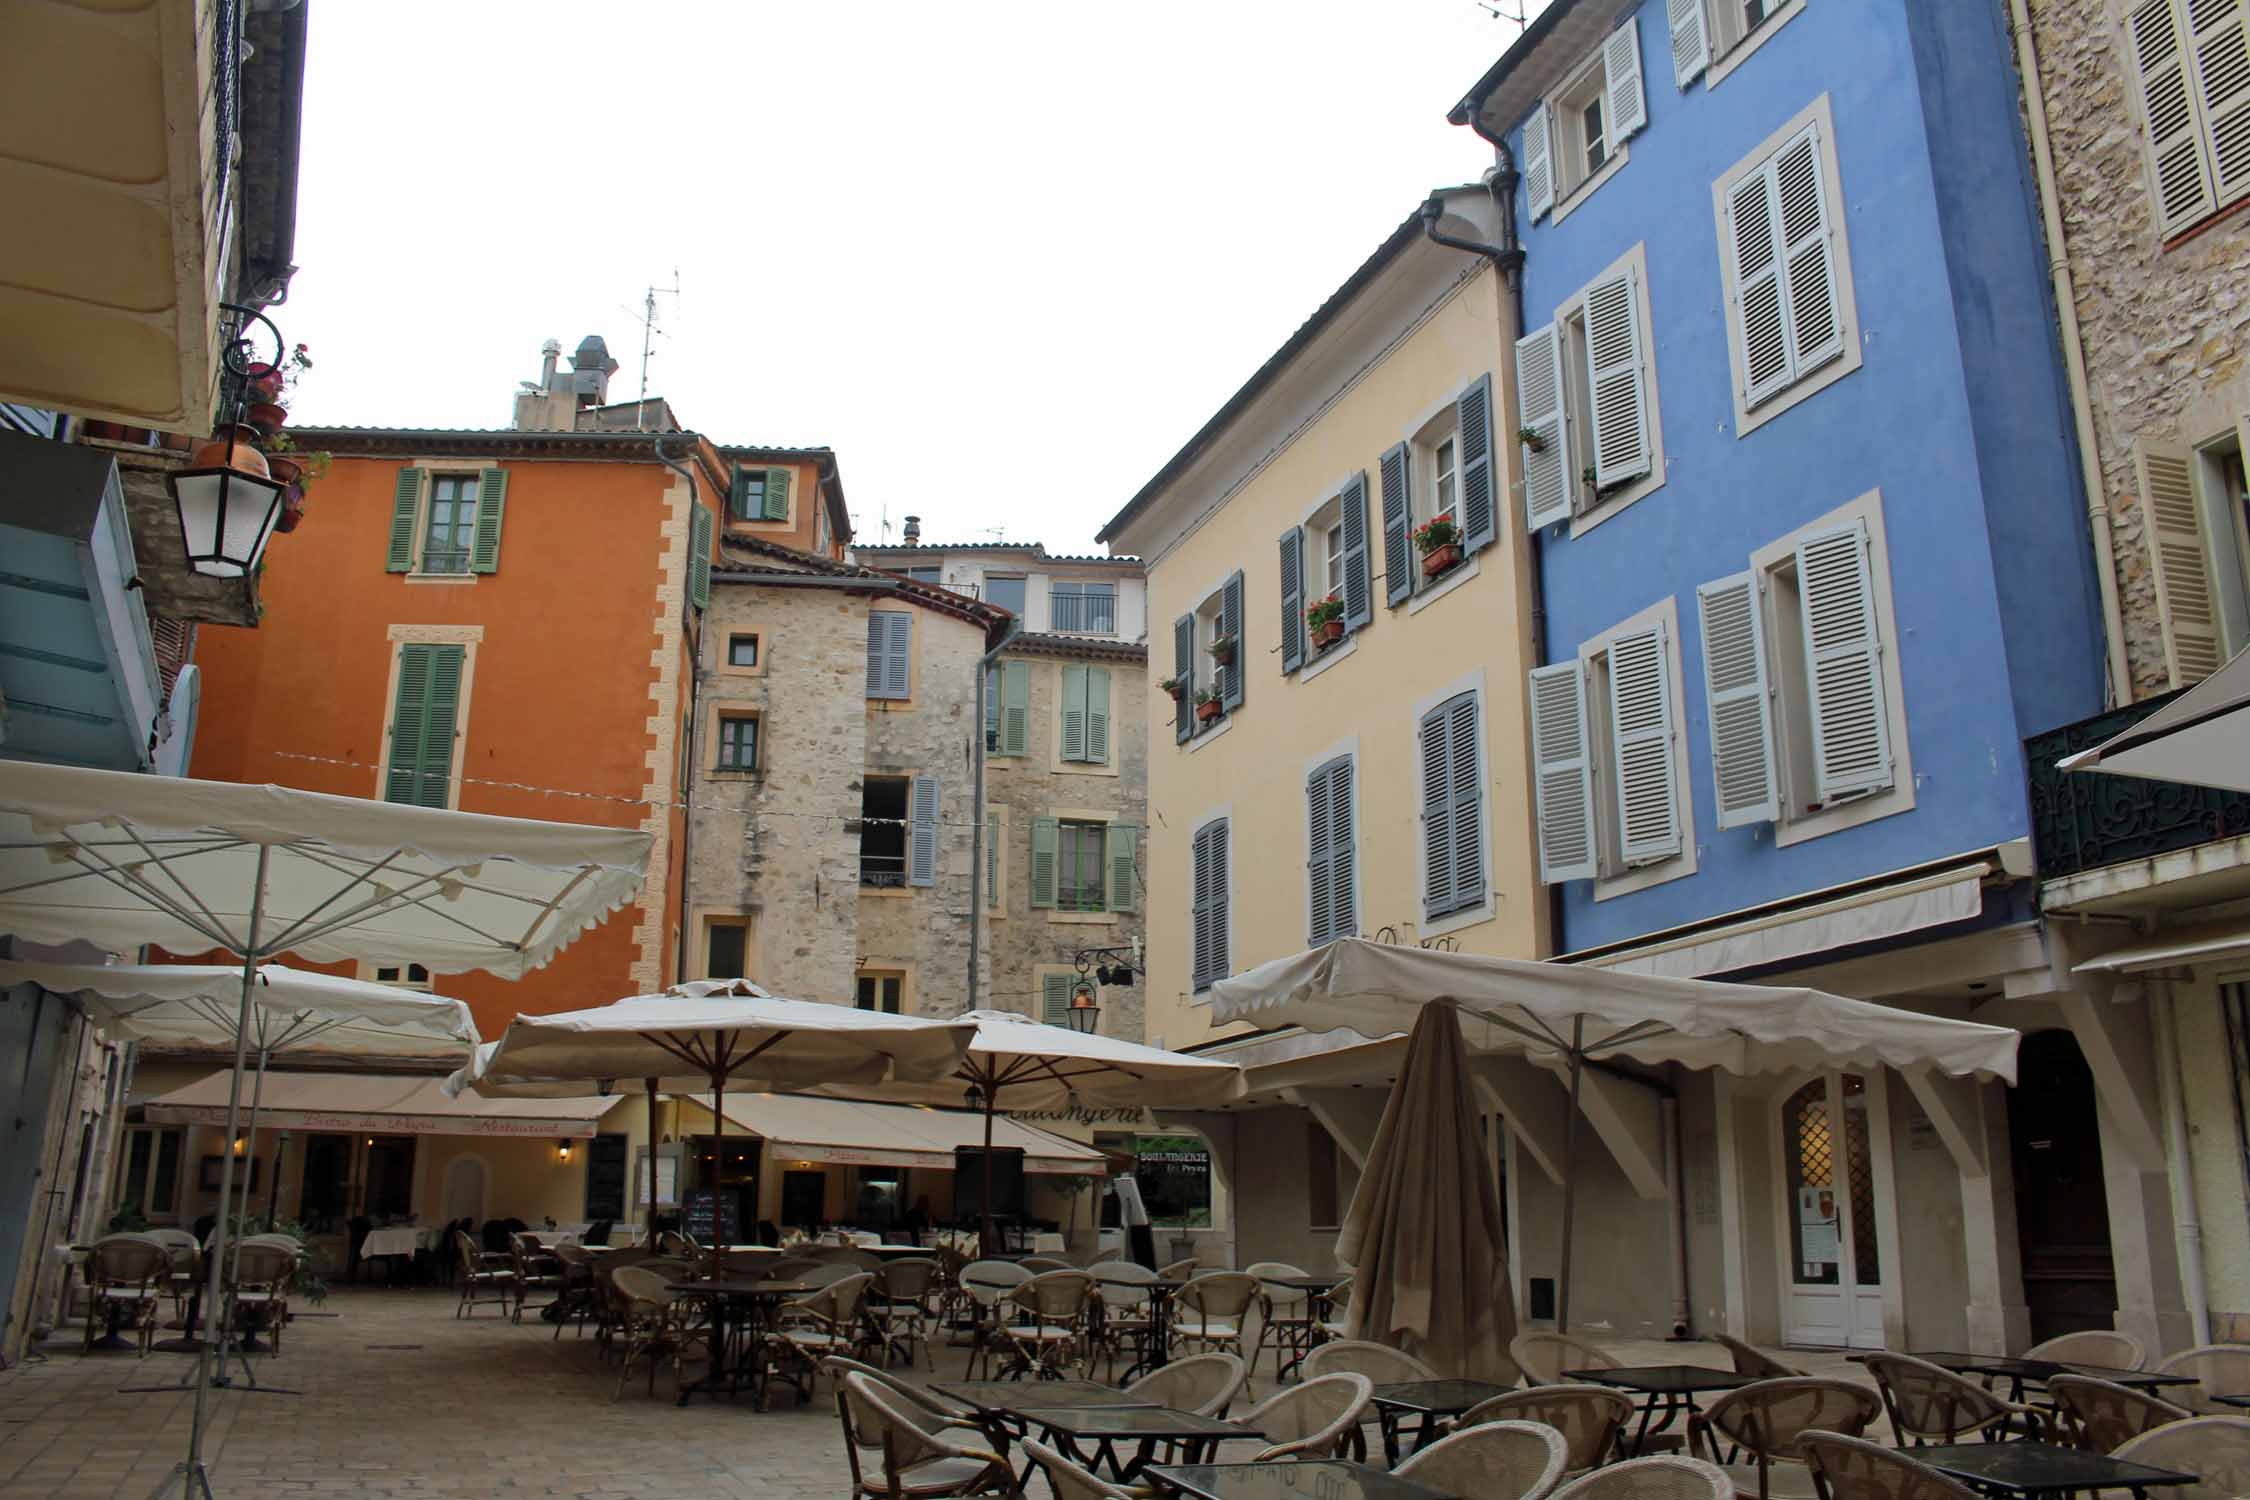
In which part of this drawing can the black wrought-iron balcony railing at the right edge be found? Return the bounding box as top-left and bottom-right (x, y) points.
(2023, 693), (2250, 879)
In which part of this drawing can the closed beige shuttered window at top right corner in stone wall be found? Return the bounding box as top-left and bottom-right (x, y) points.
(2126, 0), (2250, 238)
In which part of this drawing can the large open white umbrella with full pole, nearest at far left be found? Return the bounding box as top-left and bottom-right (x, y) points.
(0, 760), (653, 1496)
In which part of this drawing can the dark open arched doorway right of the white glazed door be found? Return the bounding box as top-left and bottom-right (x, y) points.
(2007, 1030), (2117, 1340)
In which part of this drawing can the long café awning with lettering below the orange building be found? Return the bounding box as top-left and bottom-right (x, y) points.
(144, 1073), (617, 1140)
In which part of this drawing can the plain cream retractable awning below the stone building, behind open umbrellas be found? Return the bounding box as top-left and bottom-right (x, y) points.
(695, 1093), (1109, 1176)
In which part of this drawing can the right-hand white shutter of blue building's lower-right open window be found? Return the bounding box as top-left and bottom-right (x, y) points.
(1798, 522), (1890, 807)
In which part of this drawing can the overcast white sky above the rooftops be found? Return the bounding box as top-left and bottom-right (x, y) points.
(277, 0), (1539, 551)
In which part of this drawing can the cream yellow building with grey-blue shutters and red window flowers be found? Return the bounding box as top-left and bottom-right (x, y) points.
(1100, 187), (1548, 1266)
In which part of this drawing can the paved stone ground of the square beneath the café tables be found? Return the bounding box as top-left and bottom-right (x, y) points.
(0, 1289), (1856, 1500)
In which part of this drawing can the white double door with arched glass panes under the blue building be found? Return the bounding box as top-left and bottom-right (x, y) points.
(1778, 1073), (1883, 1349)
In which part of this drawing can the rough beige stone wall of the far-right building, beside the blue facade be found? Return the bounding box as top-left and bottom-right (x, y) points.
(2030, 0), (2250, 697)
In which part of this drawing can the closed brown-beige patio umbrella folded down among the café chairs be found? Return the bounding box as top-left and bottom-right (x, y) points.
(1337, 1003), (1519, 1385)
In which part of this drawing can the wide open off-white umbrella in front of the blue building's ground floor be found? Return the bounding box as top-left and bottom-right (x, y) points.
(1211, 938), (2021, 1331)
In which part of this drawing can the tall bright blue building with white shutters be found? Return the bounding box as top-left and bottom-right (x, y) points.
(1454, 0), (2185, 1354)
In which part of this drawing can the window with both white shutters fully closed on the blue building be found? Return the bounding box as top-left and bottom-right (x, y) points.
(1717, 94), (1859, 434)
